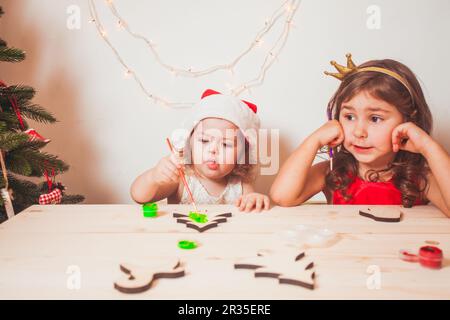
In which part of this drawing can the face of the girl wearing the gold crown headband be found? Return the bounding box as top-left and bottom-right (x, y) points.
(339, 91), (403, 168)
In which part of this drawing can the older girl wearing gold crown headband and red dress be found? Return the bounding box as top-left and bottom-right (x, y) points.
(270, 54), (450, 216)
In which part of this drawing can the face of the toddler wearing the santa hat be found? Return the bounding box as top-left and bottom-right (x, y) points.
(190, 118), (239, 180)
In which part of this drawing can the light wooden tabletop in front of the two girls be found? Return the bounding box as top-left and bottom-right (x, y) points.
(0, 205), (450, 299)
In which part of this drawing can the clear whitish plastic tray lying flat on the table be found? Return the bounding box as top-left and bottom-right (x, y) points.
(278, 224), (338, 247)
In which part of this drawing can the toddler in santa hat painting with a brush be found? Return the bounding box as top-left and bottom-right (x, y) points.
(131, 90), (269, 212)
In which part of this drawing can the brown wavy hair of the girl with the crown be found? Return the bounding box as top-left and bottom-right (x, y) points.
(325, 59), (432, 208)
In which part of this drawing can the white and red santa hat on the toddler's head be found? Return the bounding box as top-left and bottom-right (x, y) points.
(178, 89), (260, 163)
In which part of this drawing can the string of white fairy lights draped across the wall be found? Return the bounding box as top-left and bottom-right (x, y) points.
(88, 0), (301, 108)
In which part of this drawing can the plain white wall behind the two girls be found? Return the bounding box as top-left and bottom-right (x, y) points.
(0, 0), (450, 203)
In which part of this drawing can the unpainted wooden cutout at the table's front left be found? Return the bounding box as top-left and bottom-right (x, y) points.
(114, 259), (184, 293)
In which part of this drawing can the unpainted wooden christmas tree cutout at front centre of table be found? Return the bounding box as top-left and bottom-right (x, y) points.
(234, 252), (315, 290)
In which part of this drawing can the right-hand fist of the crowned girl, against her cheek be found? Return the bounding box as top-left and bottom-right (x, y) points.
(392, 122), (431, 154)
